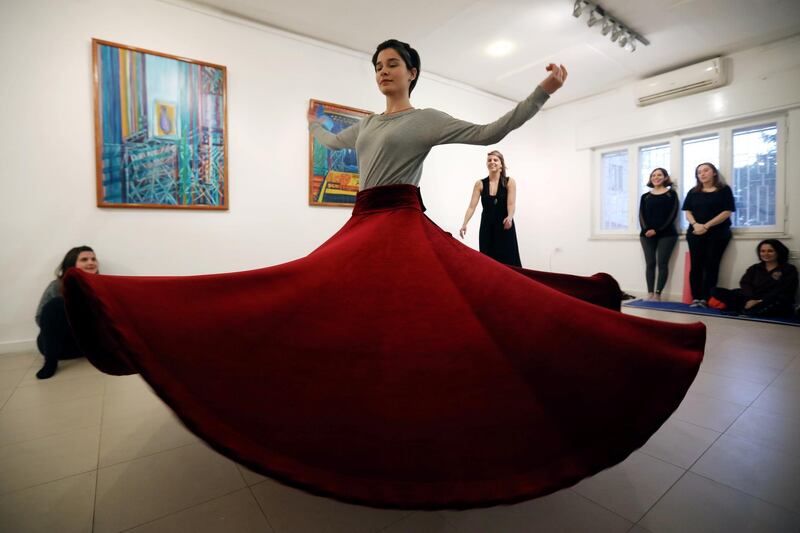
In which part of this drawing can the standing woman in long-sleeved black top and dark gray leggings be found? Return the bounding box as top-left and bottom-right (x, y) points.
(639, 168), (680, 300)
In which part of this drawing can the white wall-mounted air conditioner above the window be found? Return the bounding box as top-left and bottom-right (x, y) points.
(634, 57), (727, 106)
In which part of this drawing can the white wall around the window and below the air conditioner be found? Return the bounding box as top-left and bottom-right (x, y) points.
(512, 37), (800, 298)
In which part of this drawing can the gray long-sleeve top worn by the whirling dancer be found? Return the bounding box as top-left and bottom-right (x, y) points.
(310, 86), (550, 190)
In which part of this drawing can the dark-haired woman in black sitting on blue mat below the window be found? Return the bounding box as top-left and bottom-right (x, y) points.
(710, 239), (797, 317)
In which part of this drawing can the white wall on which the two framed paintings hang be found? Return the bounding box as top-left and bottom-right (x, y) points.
(0, 0), (513, 352)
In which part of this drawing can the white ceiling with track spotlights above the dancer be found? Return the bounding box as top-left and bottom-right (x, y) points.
(184, 0), (800, 104)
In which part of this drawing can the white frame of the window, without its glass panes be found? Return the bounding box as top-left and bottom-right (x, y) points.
(590, 113), (788, 240)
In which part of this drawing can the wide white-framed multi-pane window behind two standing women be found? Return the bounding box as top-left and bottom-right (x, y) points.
(592, 117), (786, 238)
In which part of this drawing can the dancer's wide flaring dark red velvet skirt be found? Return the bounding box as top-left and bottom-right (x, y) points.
(64, 185), (705, 509)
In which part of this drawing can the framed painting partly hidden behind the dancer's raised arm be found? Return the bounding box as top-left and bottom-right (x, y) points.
(308, 100), (372, 207)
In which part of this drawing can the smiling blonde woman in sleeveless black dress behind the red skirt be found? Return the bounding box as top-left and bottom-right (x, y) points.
(458, 150), (522, 267)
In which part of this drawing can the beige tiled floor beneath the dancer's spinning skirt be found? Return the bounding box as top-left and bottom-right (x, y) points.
(0, 310), (800, 533)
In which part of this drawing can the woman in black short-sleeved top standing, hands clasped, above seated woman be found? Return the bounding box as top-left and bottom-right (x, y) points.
(683, 163), (736, 307)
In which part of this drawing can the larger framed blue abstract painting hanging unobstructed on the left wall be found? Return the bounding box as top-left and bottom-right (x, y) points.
(92, 39), (228, 209)
